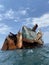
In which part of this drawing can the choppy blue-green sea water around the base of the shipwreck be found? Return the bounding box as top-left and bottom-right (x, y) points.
(0, 44), (49, 65)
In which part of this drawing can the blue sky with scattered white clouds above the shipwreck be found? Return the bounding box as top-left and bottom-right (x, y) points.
(0, 0), (49, 48)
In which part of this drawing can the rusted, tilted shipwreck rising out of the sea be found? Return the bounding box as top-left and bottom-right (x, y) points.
(2, 24), (43, 50)
